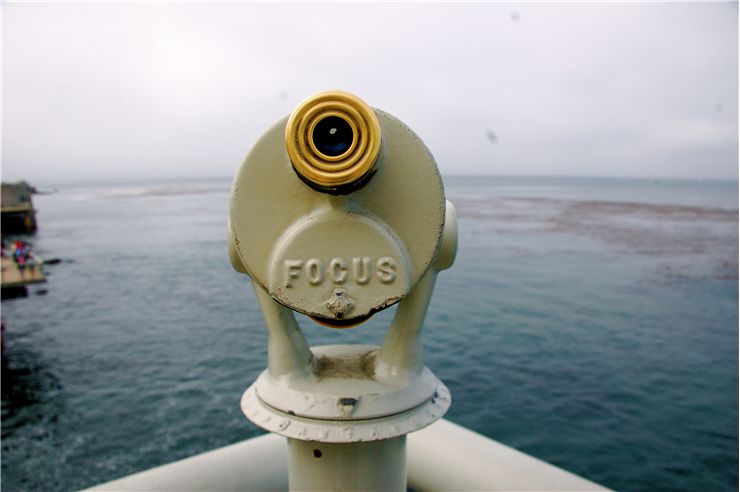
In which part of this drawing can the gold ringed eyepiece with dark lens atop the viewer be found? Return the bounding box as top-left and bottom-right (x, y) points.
(285, 91), (380, 191)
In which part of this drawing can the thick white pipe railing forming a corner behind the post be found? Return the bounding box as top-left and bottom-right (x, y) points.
(88, 419), (608, 492)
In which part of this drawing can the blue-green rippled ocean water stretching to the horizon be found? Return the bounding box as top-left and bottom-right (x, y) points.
(2, 176), (738, 491)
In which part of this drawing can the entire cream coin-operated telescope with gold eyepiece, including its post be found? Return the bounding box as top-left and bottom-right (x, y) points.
(229, 91), (457, 490)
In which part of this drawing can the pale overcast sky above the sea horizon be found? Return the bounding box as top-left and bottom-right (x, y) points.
(0, 3), (738, 182)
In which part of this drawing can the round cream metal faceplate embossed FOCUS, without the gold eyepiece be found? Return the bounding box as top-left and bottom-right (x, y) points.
(229, 111), (446, 321)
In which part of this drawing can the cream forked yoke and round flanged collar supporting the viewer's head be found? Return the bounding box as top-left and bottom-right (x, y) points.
(237, 203), (457, 443)
